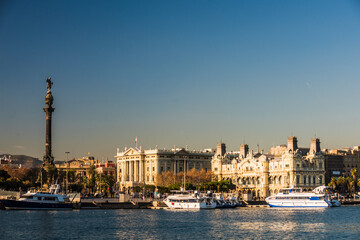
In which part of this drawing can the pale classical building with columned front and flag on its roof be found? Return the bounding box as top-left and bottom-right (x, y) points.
(115, 148), (213, 189)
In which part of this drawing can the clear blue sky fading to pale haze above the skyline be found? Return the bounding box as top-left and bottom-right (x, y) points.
(0, 0), (360, 160)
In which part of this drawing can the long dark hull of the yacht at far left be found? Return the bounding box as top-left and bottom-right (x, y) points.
(0, 200), (73, 210)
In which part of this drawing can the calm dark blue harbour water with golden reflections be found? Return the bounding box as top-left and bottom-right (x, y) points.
(0, 206), (360, 239)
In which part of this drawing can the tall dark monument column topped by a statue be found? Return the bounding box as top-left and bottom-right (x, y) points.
(43, 78), (55, 170)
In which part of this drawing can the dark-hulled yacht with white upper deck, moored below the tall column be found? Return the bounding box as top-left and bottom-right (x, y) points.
(0, 184), (73, 210)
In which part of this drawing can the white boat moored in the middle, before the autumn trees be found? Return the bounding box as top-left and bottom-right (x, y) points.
(164, 192), (216, 209)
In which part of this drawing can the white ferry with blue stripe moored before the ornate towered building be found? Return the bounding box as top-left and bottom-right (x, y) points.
(265, 186), (341, 208)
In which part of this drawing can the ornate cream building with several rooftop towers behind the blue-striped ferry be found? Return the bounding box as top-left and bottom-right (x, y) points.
(212, 137), (325, 198)
